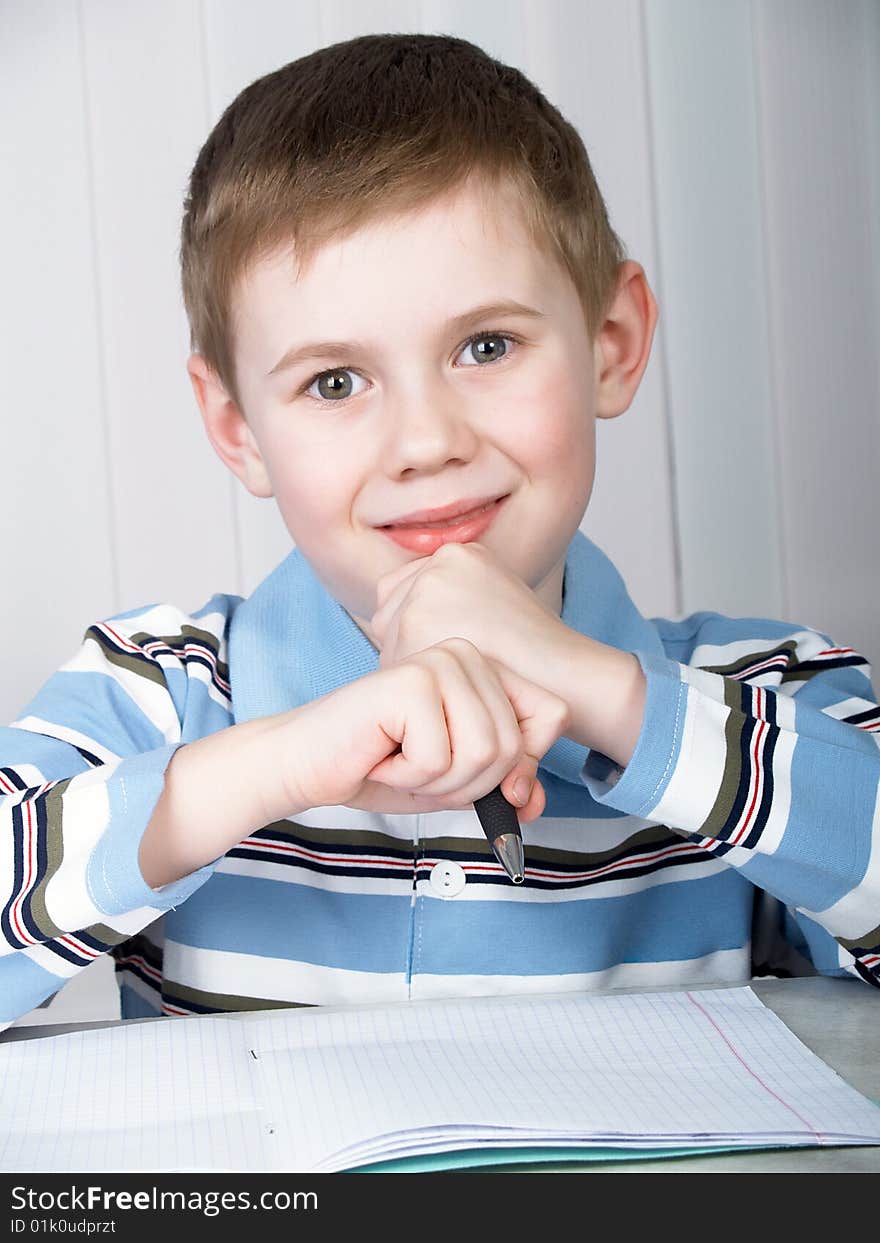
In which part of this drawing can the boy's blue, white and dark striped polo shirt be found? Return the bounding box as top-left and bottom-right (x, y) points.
(0, 532), (880, 1028)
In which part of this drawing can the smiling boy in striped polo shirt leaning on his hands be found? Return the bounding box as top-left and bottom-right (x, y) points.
(0, 35), (880, 1023)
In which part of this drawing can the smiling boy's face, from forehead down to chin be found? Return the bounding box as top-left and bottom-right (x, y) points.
(194, 177), (641, 635)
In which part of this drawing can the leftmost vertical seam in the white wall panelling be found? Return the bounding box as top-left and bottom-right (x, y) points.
(76, 0), (122, 613)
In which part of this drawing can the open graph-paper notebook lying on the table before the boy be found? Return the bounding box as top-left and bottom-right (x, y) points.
(0, 987), (880, 1172)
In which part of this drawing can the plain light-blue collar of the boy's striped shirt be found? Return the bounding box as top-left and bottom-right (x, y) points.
(229, 531), (662, 784)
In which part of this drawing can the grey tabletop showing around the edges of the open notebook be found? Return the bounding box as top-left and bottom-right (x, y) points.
(0, 976), (880, 1173)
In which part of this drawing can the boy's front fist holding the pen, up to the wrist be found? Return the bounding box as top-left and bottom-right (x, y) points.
(269, 639), (568, 822)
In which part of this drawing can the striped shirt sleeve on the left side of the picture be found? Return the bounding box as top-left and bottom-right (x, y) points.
(0, 597), (235, 1030)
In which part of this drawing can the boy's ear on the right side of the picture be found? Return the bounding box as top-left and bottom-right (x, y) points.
(594, 260), (658, 419)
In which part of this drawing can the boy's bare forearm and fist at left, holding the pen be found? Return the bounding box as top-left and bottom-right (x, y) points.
(138, 639), (568, 889)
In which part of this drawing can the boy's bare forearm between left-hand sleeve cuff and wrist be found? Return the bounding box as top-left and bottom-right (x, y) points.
(138, 712), (297, 889)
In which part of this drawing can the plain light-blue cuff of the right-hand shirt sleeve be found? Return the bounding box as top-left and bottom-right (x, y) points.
(580, 651), (687, 819)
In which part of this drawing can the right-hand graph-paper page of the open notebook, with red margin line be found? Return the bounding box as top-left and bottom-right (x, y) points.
(242, 988), (880, 1170)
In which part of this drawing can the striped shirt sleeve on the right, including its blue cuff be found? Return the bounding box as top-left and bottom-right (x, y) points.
(582, 614), (880, 986)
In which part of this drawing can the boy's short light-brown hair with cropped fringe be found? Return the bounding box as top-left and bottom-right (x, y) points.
(180, 34), (625, 406)
